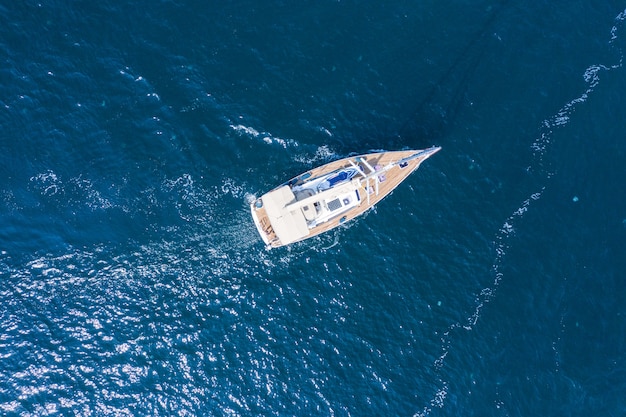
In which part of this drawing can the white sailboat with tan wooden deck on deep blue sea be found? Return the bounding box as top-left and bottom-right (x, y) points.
(250, 146), (441, 248)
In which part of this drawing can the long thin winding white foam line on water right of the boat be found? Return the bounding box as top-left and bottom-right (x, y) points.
(414, 9), (626, 417)
